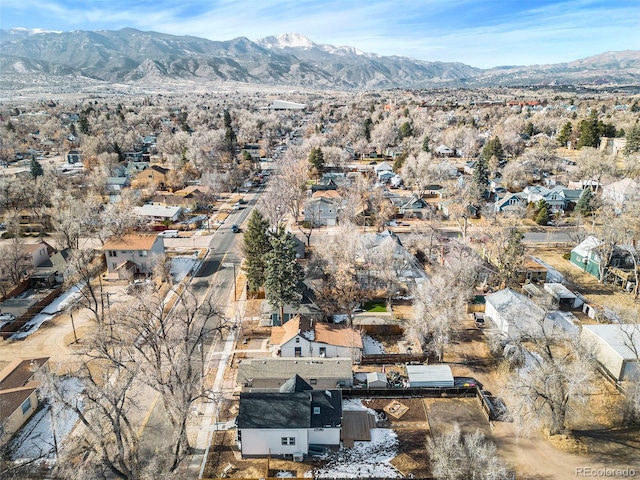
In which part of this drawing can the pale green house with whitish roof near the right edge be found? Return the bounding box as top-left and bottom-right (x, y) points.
(569, 235), (638, 279)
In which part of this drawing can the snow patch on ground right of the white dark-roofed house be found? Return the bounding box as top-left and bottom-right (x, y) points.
(305, 428), (401, 478)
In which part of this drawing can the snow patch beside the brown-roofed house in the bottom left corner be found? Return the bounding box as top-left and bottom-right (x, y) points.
(9, 377), (82, 463)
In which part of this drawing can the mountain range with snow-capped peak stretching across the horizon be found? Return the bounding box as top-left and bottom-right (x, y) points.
(0, 28), (640, 89)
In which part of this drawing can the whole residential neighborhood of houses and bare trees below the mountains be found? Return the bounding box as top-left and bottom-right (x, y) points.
(0, 77), (640, 479)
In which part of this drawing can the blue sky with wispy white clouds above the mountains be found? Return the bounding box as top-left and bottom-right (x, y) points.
(0, 0), (640, 68)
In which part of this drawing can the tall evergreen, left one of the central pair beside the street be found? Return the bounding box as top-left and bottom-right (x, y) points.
(242, 209), (271, 292)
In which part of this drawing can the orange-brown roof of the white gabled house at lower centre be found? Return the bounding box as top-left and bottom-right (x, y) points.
(271, 315), (362, 348)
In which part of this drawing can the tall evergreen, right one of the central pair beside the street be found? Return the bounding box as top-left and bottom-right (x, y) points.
(264, 227), (304, 321)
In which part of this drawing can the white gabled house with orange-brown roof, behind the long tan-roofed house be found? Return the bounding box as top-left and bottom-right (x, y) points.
(270, 315), (363, 363)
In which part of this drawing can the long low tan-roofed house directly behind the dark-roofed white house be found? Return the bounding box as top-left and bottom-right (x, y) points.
(236, 357), (353, 392)
